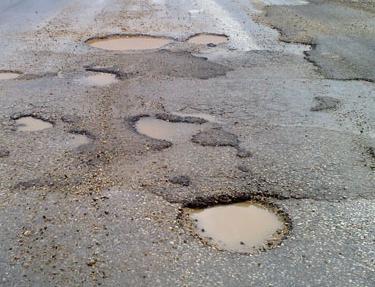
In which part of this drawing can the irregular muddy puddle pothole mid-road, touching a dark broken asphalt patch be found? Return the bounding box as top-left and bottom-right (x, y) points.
(135, 117), (200, 143)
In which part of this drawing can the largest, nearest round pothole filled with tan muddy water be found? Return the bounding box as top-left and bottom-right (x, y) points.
(187, 201), (287, 253)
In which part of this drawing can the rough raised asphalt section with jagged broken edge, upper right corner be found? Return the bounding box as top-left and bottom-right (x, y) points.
(265, 0), (375, 82)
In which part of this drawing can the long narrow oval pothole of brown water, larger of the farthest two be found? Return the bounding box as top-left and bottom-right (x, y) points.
(86, 35), (173, 51)
